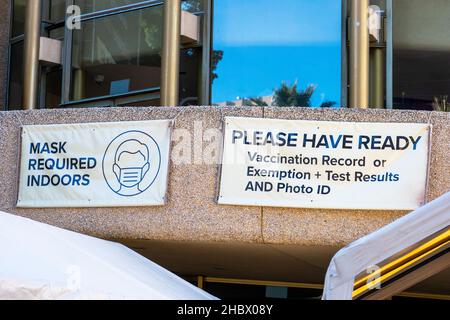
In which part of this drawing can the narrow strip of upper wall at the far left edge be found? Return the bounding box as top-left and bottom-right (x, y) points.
(0, 0), (11, 110)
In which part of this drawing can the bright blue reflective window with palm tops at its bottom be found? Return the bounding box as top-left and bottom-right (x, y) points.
(212, 0), (342, 106)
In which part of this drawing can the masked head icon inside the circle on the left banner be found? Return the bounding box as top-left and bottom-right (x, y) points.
(113, 140), (150, 194)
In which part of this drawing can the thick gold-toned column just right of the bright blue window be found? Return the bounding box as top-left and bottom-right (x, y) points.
(350, 0), (369, 108)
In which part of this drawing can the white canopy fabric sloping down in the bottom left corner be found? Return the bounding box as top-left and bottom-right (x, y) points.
(0, 212), (216, 300)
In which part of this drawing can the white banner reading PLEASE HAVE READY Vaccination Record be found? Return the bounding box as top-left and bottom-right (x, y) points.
(218, 118), (431, 210)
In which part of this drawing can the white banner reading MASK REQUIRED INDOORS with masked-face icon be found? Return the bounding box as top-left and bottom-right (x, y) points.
(17, 120), (172, 208)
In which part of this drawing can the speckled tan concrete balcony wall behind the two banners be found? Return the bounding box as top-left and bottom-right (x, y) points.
(0, 107), (450, 247)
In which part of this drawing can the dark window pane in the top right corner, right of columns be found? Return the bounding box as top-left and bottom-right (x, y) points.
(393, 0), (450, 110)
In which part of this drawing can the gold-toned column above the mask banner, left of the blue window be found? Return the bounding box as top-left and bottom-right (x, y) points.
(161, 0), (181, 106)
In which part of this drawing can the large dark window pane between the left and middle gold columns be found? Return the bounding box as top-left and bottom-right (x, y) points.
(71, 6), (163, 100)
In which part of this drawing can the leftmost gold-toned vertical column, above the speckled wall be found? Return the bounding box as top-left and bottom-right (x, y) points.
(23, 0), (42, 110)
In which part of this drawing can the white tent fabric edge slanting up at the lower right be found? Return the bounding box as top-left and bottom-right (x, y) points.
(323, 192), (450, 300)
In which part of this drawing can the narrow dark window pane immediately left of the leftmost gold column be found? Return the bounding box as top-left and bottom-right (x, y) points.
(8, 41), (23, 110)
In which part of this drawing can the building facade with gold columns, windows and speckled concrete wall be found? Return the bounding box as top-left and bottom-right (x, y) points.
(0, 0), (450, 298)
